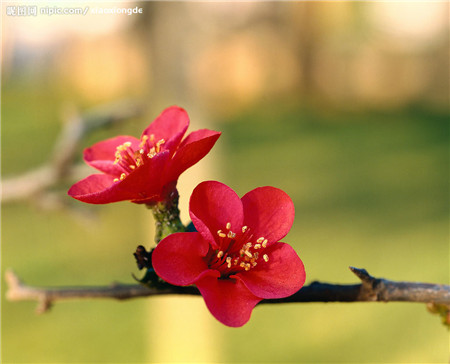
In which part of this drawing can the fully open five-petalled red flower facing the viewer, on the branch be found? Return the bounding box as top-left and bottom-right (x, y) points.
(152, 181), (305, 327)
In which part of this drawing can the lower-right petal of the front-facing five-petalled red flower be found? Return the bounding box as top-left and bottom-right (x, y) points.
(236, 243), (306, 299)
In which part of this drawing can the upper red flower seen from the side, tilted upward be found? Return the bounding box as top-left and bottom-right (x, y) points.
(68, 106), (220, 204)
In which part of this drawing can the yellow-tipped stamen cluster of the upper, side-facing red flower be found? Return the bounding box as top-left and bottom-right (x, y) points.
(114, 134), (165, 182)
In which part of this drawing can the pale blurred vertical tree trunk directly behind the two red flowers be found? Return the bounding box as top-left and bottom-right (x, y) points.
(132, 1), (221, 363)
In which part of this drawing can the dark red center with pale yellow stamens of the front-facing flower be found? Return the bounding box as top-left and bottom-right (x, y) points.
(207, 223), (269, 278)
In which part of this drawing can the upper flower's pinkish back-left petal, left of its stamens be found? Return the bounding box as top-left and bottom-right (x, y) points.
(83, 135), (140, 176)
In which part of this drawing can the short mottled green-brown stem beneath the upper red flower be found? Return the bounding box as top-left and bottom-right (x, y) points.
(147, 191), (186, 244)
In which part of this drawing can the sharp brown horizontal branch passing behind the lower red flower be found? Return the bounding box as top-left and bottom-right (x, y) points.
(5, 267), (450, 313)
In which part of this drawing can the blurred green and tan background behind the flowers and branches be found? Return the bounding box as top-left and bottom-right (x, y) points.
(1, 2), (449, 363)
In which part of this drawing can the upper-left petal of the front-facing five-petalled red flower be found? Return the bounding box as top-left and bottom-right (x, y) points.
(189, 181), (244, 248)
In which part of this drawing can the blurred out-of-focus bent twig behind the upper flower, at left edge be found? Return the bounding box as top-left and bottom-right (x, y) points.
(2, 100), (143, 205)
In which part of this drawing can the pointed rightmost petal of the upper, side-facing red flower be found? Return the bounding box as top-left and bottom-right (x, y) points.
(167, 129), (221, 181)
